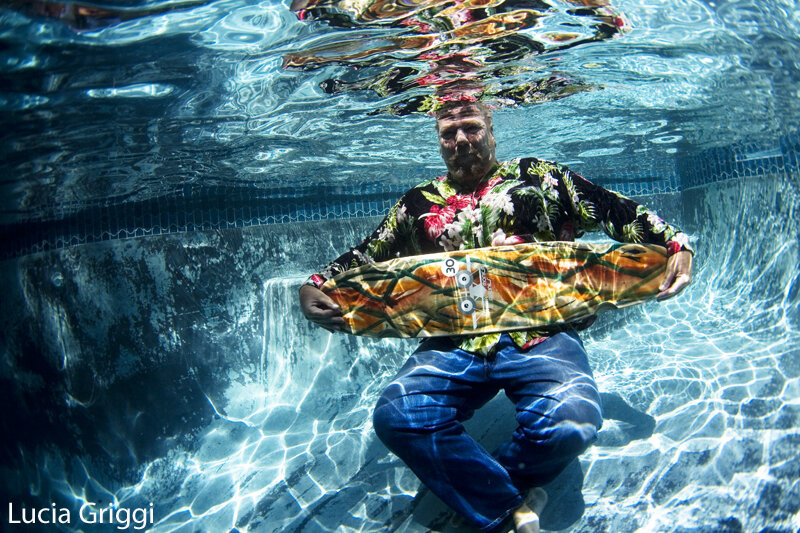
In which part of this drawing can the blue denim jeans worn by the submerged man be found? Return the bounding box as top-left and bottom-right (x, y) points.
(373, 332), (603, 531)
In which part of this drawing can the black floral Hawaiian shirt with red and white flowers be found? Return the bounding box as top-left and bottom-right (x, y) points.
(306, 158), (692, 355)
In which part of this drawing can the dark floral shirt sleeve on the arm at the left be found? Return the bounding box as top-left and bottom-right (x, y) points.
(298, 196), (416, 288)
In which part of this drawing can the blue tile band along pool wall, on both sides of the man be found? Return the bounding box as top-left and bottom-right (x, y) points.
(0, 135), (800, 259)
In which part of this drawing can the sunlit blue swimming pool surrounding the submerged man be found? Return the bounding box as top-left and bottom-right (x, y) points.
(0, 1), (800, 532)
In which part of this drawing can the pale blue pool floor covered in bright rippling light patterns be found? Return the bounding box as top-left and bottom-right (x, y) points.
(50, 278), (800, 532)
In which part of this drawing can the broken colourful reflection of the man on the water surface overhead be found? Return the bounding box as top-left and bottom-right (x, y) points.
(283, 0), (631, 115)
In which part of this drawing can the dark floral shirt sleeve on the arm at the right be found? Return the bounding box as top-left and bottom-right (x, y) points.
(560, 167), (694, 255)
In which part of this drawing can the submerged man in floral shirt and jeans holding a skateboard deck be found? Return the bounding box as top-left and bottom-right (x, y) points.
(300, 96), (693, 533)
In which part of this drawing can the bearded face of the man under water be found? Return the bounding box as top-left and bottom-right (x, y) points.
(436, 105), (496, 183)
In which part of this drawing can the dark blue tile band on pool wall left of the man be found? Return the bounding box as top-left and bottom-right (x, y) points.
(0, 186), (400, 259)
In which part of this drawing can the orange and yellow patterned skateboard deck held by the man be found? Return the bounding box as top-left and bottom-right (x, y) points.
(322, 242), (667, 337)
